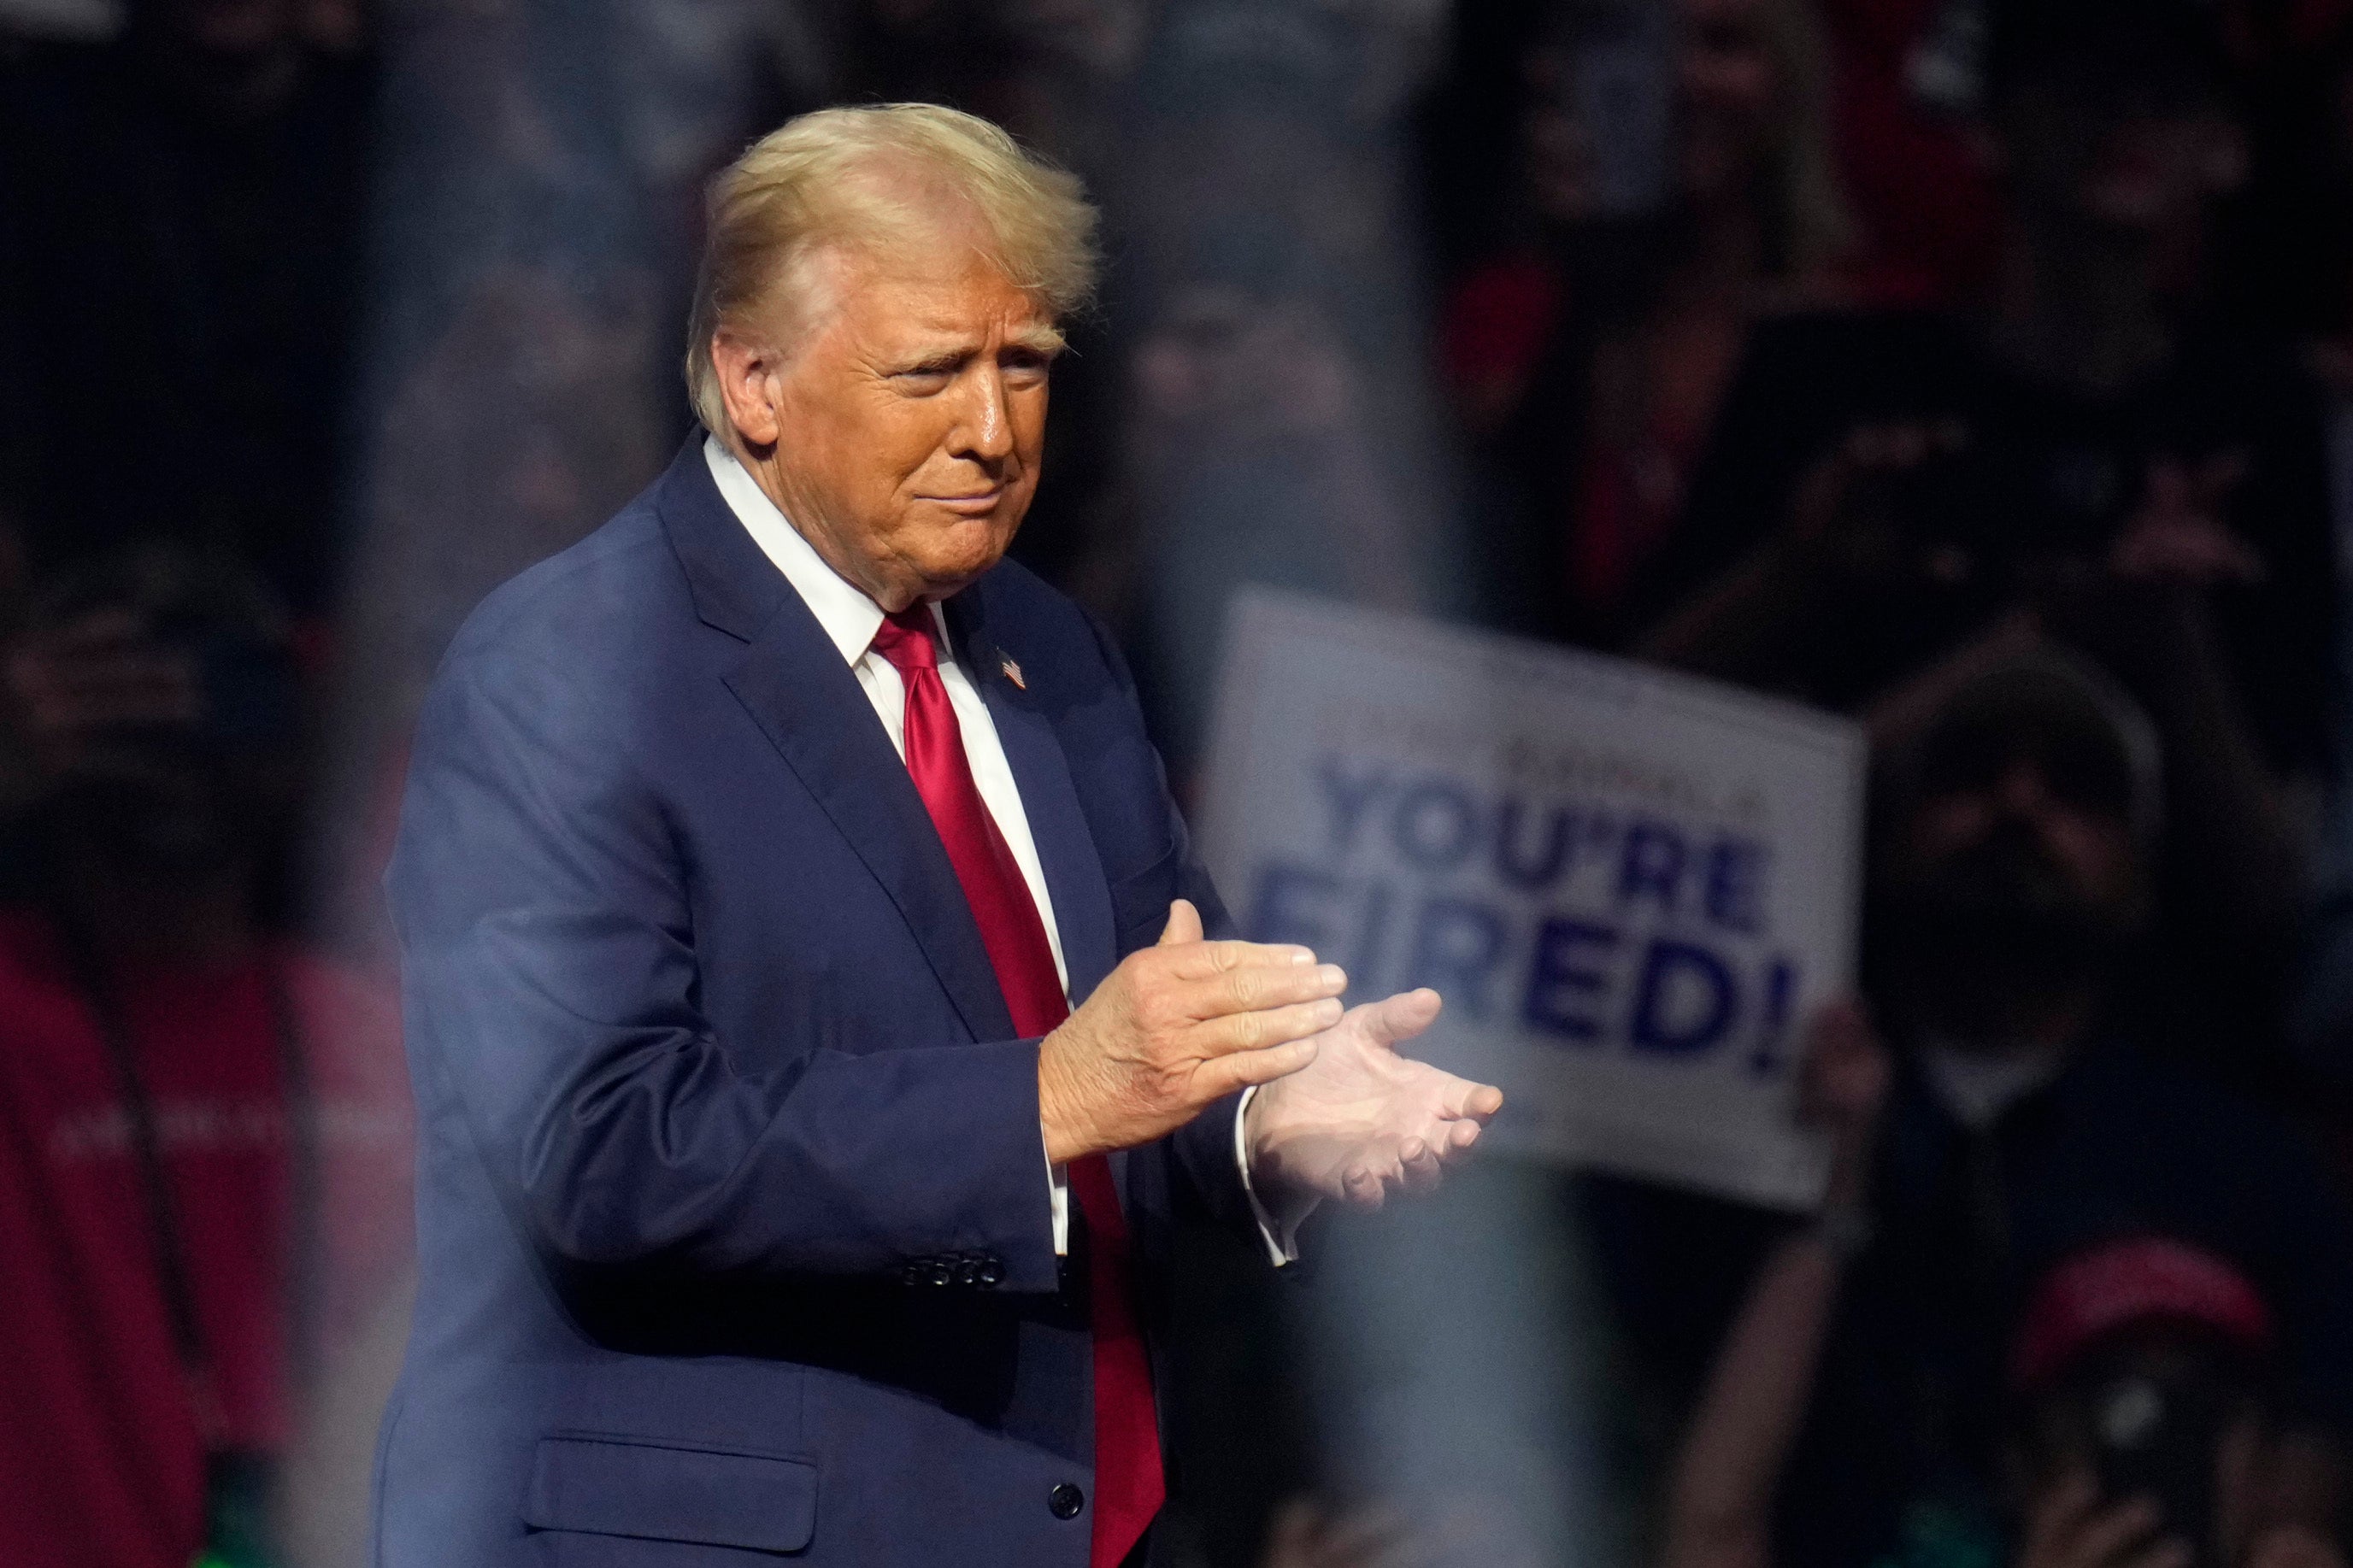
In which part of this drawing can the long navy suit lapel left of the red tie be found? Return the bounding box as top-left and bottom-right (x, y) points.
(659, 442), (1015, 1039)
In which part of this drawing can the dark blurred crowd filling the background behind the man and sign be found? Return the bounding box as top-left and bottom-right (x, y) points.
(0, 0), (2353, 1568)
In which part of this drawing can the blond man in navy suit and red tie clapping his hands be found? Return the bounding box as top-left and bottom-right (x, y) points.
(376, 106), (1501, 1568)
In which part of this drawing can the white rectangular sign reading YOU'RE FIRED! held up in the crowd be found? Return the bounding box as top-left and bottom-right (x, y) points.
(1200, 590), (1863, 1206)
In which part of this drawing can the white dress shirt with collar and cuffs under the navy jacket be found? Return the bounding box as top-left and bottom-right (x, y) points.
(703, 438), (1299, 1265)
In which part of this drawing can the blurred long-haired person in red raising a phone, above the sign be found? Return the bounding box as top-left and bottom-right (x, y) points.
(1440, 0), (1852, 649)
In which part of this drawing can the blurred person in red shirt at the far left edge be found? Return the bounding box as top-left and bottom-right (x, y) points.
(0, 550), (409, 1568)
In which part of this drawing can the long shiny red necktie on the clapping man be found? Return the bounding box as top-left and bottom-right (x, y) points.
(873, 604), (1165, 1568)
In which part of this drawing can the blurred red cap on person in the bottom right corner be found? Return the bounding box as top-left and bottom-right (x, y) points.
(2009, 1236), (2273, 1392)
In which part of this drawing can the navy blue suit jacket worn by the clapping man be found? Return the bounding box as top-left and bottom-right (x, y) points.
(376, 442), (1247, 1568)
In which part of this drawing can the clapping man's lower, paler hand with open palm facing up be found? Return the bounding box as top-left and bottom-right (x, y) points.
(1243, 990), (1503, 1230)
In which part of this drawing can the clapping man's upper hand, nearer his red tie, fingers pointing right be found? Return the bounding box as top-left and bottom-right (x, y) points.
(1038, 898), (1348, 1166)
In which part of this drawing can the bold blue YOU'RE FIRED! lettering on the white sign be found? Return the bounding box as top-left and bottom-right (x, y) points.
(1247, 757), (1803, 1077)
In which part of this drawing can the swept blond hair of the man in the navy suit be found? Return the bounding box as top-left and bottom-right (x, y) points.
(687, 103), (1097, 439)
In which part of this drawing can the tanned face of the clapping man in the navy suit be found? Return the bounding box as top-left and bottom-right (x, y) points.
(713, 228), (1062, 611)
